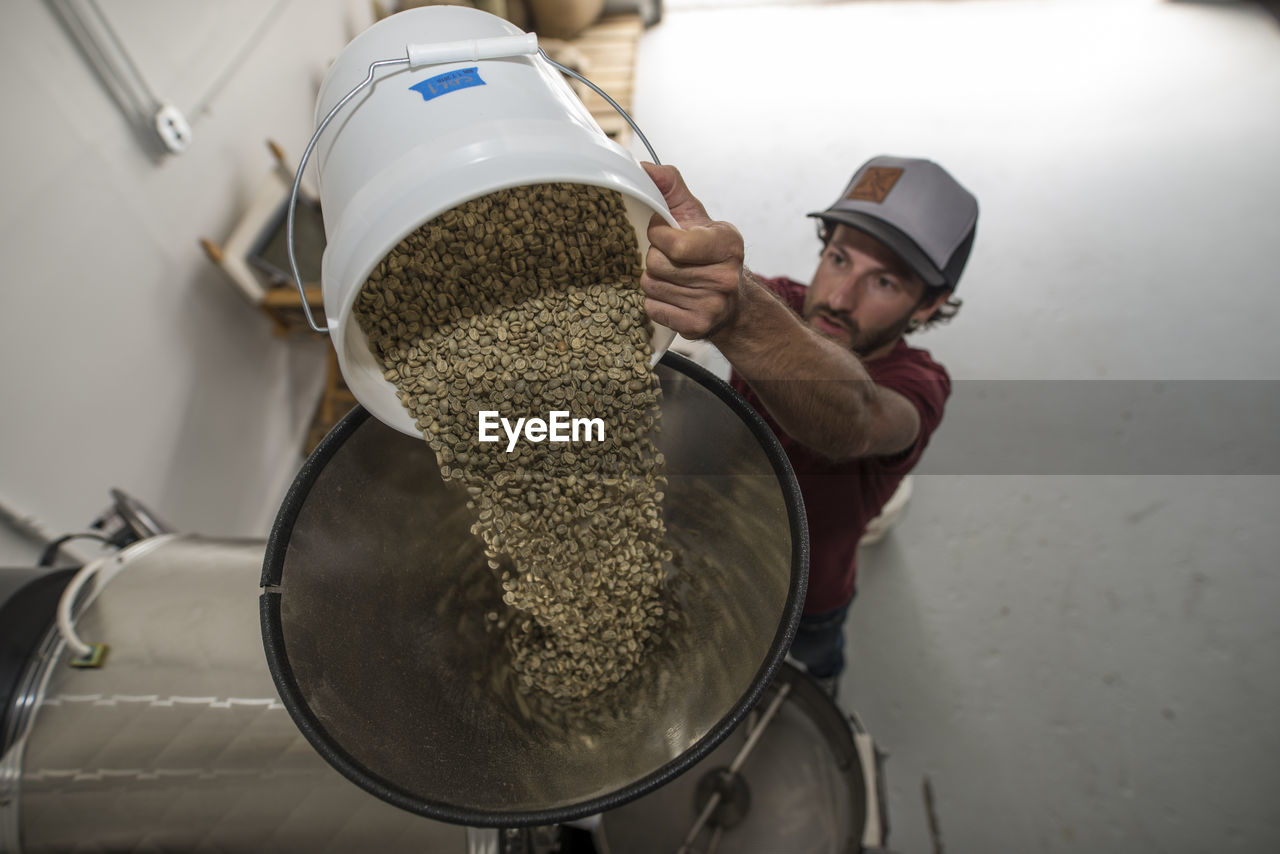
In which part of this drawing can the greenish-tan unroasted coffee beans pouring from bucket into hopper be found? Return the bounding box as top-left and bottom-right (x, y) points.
(355, 184), (671, 699)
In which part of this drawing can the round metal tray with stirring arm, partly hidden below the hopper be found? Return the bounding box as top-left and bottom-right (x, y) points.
(594, 665), (879, 854)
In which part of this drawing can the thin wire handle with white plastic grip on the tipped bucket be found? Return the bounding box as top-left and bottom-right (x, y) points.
(285, 32), (662, 335)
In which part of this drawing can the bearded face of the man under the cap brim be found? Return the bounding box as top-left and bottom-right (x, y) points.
(804, 225), (933, 359)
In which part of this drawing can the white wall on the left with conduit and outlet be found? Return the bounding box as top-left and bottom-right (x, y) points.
(0, 0), (369, 565)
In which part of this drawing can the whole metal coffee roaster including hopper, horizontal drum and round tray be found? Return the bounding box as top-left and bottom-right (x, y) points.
(0, 355), (887, 854)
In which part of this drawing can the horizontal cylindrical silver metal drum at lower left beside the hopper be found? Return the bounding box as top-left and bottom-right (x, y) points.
(0, 535), (467, 854)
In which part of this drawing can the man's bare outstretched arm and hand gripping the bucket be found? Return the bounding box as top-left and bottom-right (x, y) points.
(640, 164), (920, 461)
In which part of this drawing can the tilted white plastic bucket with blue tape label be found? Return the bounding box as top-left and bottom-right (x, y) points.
(315, 6), (676, 435)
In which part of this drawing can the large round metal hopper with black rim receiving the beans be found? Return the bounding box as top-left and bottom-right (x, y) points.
(261, 353), (808, 827)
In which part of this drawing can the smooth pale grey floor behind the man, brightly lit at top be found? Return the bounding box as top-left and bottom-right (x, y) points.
(635, 0), (1280, 853)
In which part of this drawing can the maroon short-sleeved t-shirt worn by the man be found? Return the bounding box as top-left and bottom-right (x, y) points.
(730, 278), (951, 613)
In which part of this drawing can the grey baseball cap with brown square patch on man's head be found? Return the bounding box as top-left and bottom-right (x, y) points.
(809, 156), (978, 294)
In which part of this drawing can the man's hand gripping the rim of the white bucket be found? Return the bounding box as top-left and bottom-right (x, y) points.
(640, 163), (745, 338)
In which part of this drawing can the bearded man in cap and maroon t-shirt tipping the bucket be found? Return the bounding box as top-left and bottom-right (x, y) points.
(640, 157), (978, 695)
